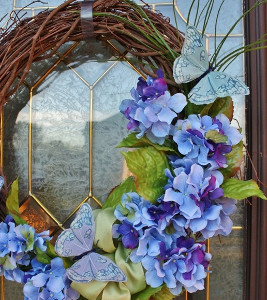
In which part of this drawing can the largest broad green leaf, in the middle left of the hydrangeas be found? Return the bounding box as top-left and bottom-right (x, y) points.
(122, 147), (169, 202)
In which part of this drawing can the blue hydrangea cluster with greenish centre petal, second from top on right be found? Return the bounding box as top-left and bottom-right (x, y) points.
(171, 114), (242, 169)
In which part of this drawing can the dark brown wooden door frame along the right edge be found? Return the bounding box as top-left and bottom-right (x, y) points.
(244, 0), (267, 300)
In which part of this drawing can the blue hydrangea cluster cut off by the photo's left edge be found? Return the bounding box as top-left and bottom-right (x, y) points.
(0, 215), (50, 283)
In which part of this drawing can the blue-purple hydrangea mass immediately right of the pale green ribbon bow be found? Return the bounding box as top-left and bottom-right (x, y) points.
(113, 193), (214, 295)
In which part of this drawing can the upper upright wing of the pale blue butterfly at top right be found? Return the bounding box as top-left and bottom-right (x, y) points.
(173, 26), (209, 84)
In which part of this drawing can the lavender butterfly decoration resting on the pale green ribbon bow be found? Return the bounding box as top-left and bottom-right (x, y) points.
(55, 203), (127, 283)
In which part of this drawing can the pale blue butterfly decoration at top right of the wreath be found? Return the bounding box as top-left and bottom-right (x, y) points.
(173, 26), (249, 105)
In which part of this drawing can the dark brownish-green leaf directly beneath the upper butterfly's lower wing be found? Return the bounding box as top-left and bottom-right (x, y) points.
(200, 97), (234, 121)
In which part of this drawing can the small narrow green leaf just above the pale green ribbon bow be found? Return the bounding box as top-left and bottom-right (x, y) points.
(103, 176), (136, 208)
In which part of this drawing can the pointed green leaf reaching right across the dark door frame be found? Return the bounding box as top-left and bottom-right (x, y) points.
(221, 178), (267, 200)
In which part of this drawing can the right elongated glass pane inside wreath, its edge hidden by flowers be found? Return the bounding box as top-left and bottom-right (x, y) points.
(93, 62), (139, 202)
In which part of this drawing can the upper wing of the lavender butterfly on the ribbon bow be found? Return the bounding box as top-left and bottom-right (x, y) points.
(55, 203), (95, 256)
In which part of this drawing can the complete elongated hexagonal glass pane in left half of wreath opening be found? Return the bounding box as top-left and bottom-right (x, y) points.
(32, 63), (90, 221)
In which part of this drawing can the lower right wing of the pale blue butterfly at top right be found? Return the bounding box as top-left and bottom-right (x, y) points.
(188, 71), (249, 105)
